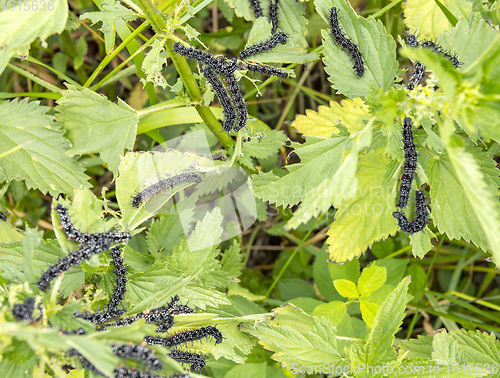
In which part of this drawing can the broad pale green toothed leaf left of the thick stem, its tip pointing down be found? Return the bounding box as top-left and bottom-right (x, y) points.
(55, 84), (139, 173)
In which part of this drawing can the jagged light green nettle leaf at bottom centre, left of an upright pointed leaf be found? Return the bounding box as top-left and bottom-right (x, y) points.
(243, 314), (346, 369)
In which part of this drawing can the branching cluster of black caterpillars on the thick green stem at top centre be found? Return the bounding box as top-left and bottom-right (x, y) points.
(174, 39), (288, 133)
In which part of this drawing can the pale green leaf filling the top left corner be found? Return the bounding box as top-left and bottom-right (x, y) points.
(0, 0), (68, 74)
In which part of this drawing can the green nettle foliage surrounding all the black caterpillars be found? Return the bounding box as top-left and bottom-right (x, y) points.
(0, 0), (500, 378)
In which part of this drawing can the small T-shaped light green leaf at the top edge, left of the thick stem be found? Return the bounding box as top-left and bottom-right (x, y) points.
(80, 0), (137, 54)
